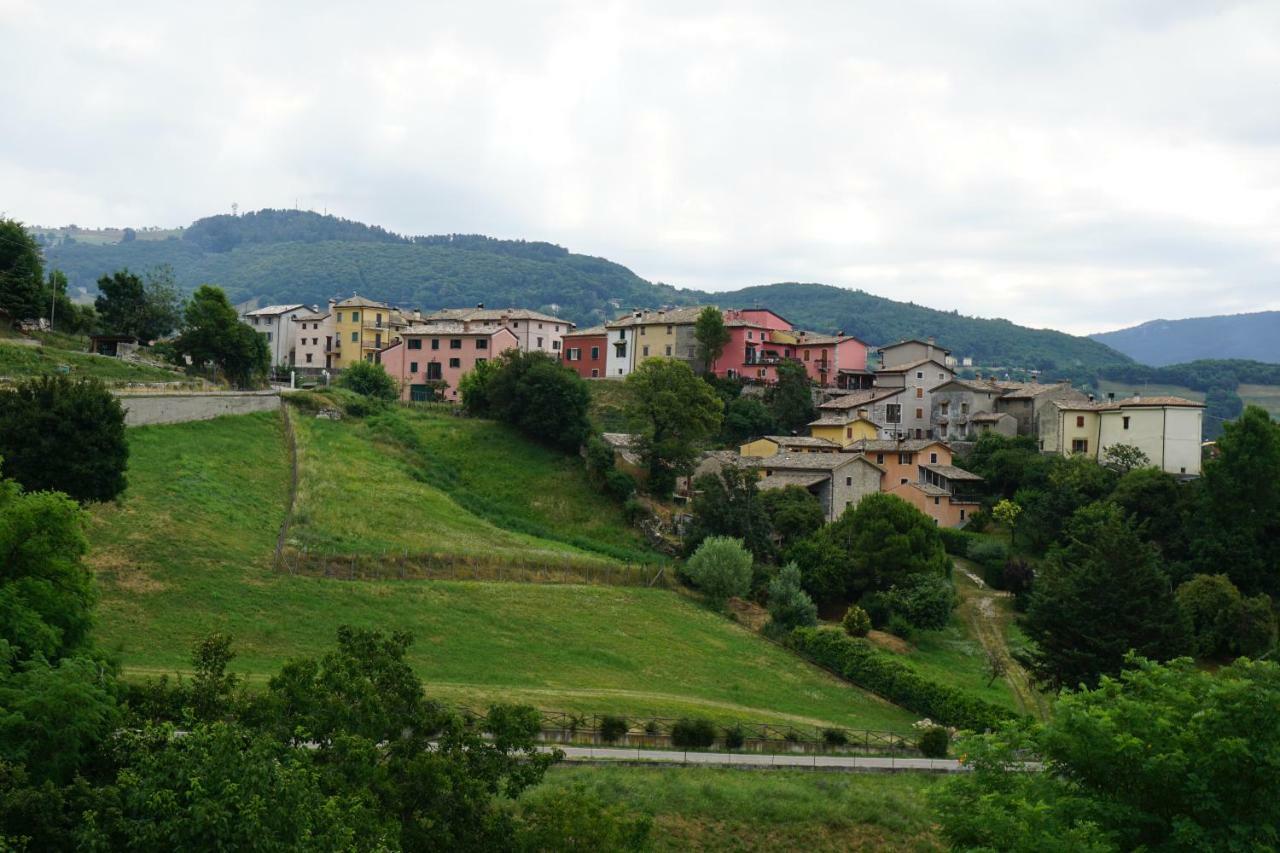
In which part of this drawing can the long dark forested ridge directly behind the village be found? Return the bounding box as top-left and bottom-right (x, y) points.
(45, 210), (1130, 377)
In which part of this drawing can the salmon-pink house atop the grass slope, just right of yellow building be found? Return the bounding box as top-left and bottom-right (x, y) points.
(379, 323), (520, 402)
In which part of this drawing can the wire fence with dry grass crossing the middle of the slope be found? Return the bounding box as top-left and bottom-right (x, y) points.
(274, 547), (676, 589)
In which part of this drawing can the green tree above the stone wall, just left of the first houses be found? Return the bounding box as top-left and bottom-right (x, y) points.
(174, 284), (271, 387)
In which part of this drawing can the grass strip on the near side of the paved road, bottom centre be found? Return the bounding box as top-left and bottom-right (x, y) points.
(522, 766), (945, 850)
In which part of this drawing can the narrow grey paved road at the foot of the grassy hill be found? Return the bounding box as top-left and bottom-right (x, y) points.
(538, 745), (965, 774)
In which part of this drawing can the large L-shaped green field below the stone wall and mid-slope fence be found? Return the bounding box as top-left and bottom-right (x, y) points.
(90, 414), (913, 730)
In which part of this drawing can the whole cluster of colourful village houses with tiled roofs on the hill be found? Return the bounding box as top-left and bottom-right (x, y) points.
(227, 296), (1204, 528)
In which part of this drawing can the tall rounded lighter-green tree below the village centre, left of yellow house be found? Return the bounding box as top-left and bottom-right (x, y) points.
(625, 359), (723, 494)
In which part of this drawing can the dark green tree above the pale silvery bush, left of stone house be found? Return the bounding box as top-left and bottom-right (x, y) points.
(685, 465), (773, 561)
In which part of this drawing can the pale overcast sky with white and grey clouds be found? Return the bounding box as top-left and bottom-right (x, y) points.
(0, 0), (1280, 333)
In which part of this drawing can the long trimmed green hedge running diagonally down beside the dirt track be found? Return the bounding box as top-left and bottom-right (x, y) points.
(791, 628), (1019, 731)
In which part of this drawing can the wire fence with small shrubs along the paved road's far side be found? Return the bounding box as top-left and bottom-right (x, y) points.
(452, 706), (920, 757)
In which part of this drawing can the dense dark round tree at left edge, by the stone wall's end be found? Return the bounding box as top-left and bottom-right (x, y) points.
(0, 377), (129, 503)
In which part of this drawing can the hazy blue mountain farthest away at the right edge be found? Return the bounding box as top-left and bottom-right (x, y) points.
(1089, 311), (1280, 366)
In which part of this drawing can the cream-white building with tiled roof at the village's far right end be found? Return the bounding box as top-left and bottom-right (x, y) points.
(1039, 396), (1204, 476)
